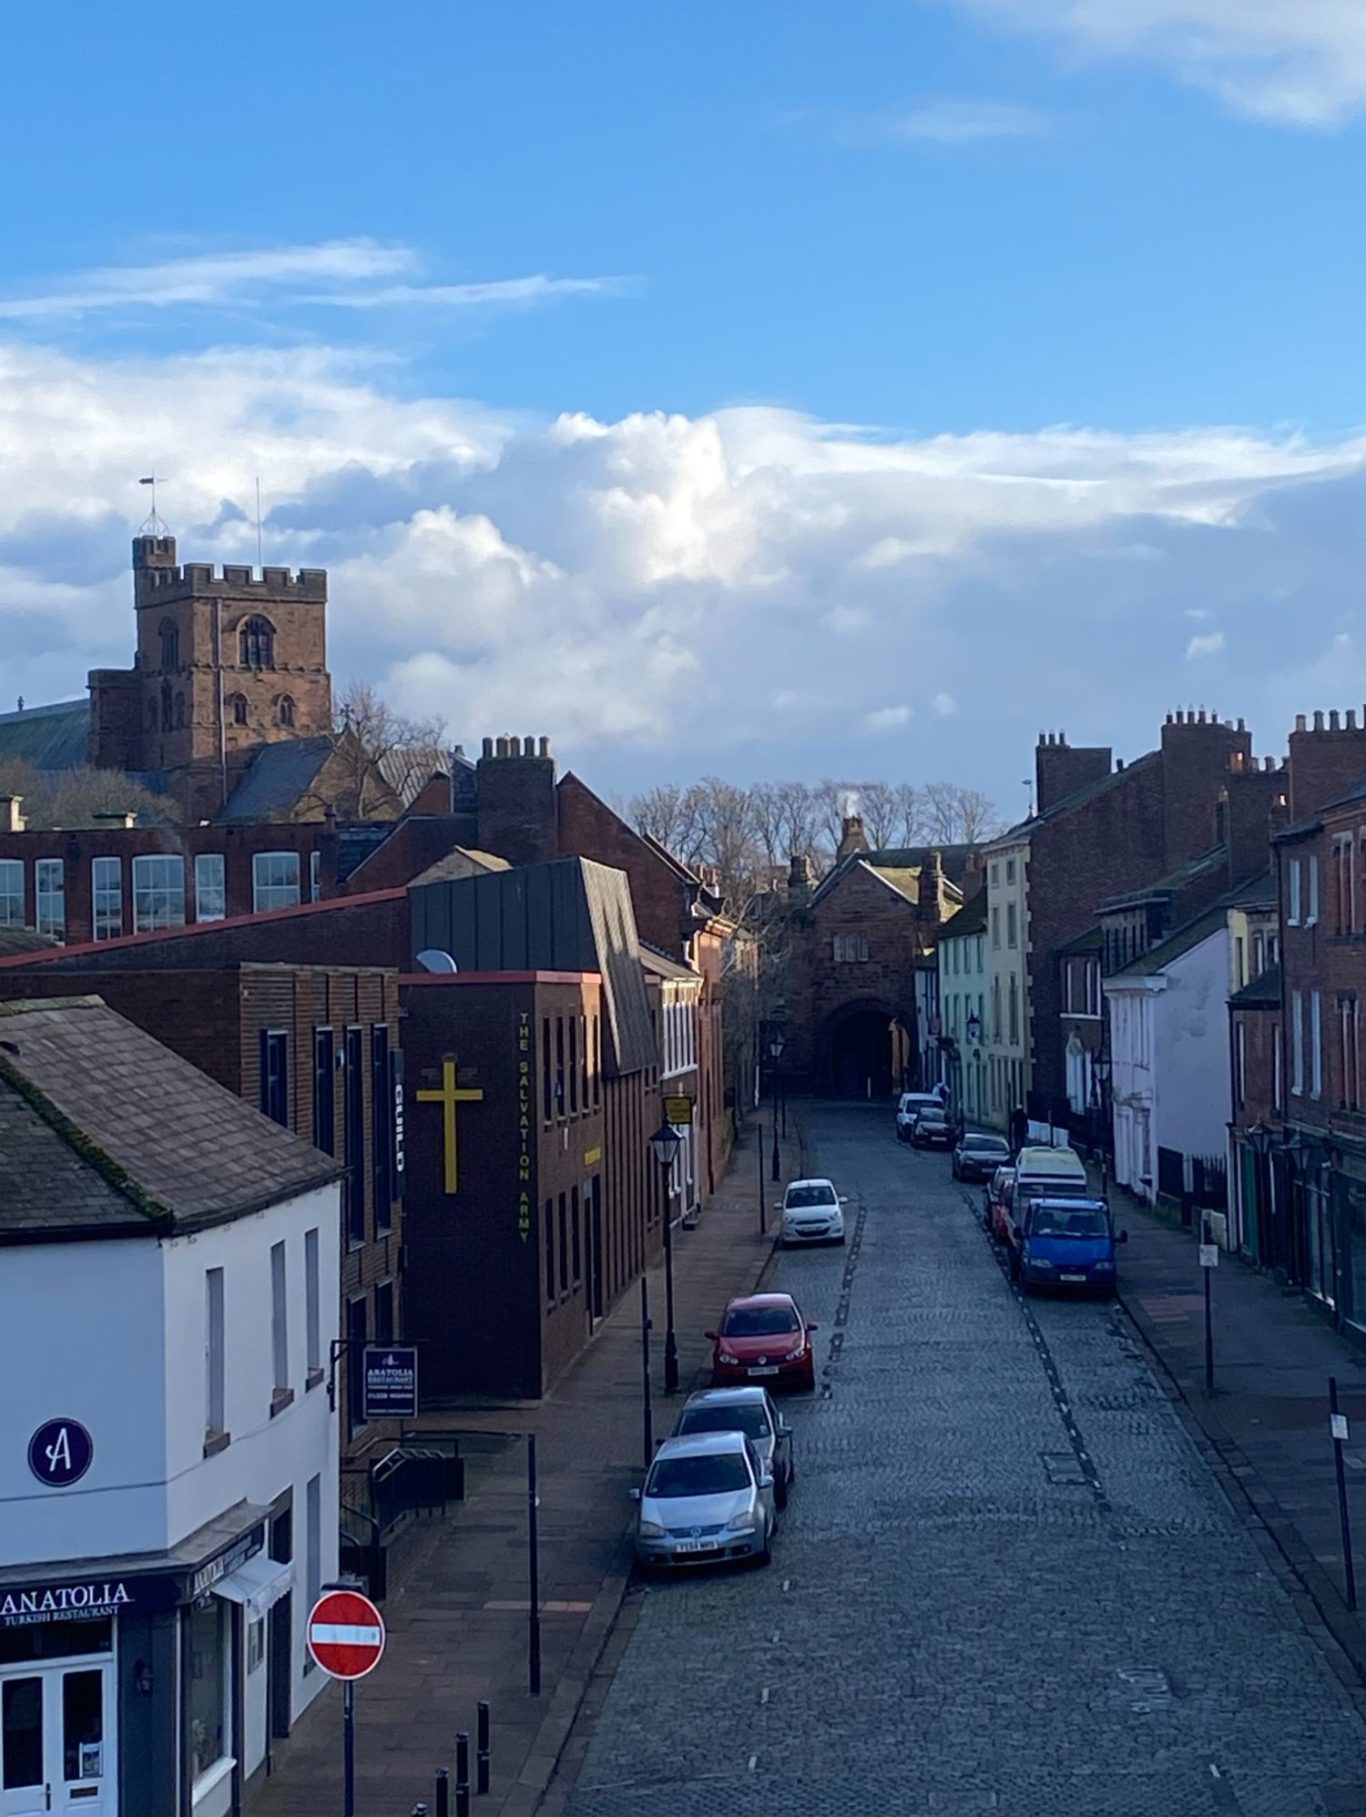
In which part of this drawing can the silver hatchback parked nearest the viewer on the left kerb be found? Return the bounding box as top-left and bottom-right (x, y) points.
(630, 1432), (777, 1568)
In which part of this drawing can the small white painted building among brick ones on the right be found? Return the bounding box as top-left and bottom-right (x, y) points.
(1104, 903), (1230, 1201)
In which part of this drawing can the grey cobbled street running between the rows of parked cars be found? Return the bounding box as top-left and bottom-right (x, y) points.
(567, 1105), (1366, 1817)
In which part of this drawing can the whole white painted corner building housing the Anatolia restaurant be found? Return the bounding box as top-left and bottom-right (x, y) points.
(0, 998), (340, 1817)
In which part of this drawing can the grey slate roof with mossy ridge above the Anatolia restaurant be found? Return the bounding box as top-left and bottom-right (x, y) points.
(0, 998), (343, 1243)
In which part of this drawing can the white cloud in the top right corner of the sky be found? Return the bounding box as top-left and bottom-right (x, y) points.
(959, 0), (1366, 127)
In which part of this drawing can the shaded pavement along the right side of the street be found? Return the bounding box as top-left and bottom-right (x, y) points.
(1110, 1187), (1366, 1673)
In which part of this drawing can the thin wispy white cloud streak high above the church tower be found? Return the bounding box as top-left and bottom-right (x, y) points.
(0, 240), (623, 322)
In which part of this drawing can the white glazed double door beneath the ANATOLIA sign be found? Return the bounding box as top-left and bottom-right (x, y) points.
(0, 1663), (118, 1817)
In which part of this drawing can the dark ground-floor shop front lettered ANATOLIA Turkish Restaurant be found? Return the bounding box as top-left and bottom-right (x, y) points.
(0, 1506), (294, 1817)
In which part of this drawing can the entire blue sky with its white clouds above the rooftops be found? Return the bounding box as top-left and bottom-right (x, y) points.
(0, 0), (1366, 798)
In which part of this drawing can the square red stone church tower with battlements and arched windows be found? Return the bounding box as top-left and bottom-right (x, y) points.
(89, 536), (332, 819)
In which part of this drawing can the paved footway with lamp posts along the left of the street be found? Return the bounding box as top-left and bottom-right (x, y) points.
(251, 1119), (801, 1817)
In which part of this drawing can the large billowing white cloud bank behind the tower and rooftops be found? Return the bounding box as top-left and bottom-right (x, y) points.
(0, 345), (1366, 799)
